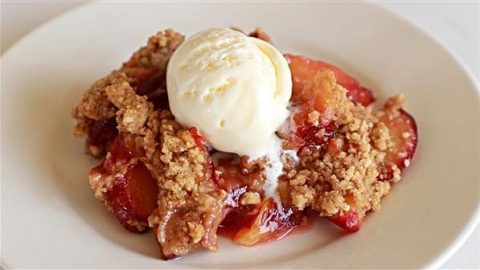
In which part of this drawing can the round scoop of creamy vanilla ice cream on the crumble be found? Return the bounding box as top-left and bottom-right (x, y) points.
(167, 28), (292, 158)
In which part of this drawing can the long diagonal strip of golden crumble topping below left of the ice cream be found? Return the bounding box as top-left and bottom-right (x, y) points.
(106, 80), (226, 258)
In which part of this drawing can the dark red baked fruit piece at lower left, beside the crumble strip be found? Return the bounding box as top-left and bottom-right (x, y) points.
(90, 136), (158, 233)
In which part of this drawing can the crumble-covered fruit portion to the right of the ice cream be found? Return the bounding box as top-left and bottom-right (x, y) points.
(286, 54), (417, 232)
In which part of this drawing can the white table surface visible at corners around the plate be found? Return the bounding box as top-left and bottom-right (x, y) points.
(1, 0), (480, 269)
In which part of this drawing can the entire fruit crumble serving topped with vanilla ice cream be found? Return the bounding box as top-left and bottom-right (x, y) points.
(73, 28), (417, 259)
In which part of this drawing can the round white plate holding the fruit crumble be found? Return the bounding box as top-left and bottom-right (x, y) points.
(1, 3), (480, 268)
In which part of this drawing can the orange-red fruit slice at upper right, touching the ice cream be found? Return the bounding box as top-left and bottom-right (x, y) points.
(285, 54), (375, 106)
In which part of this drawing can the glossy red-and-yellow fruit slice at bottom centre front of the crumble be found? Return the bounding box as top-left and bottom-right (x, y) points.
(219, 198), (305, 246)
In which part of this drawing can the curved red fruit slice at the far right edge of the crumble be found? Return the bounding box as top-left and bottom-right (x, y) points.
(378, 106), (418, 180)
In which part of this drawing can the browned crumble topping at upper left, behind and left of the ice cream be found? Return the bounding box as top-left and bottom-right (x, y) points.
(72, 29), (184, 157)
